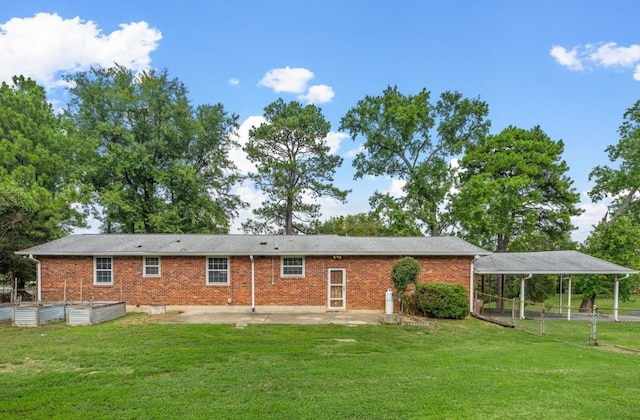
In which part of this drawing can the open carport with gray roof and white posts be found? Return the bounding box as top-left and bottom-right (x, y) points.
(471, 251), (638, 321)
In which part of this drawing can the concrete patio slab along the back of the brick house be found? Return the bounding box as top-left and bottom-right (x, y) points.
(161, 312), (381, 328)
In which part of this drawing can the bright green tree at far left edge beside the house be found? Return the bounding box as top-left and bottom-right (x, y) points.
(0, 76), (84, 284)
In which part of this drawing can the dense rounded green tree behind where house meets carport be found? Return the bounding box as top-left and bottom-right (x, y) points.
(451, 127), (581, 252)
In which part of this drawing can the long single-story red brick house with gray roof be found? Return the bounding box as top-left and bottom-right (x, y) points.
(17, 234), (490, 312)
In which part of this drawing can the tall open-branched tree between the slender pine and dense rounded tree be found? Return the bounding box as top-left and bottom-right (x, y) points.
(340, 87), (490, 236)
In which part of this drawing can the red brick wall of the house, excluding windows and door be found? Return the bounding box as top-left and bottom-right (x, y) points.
(40, 256), (471, 310)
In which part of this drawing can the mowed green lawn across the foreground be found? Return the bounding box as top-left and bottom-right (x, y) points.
(0, 314), (640, 419)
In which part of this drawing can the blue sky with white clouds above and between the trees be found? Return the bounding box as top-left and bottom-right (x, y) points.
(0, 0), (640, 240)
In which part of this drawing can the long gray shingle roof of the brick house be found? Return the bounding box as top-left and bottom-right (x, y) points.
(16, 234), (490, 257)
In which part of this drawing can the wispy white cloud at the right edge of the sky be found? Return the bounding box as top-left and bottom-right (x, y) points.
(550, 42), (640, 81)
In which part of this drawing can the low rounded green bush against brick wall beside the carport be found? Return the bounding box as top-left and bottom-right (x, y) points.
(415, 283), (469, 319)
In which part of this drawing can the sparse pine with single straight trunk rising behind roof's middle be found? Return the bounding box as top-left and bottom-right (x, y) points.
(243, 99), (348, 235)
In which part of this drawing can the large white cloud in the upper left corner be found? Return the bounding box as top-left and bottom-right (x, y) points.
(0, 13), (162, 88)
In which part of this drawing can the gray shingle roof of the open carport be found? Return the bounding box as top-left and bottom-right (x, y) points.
(473, 251), (638, 275)
